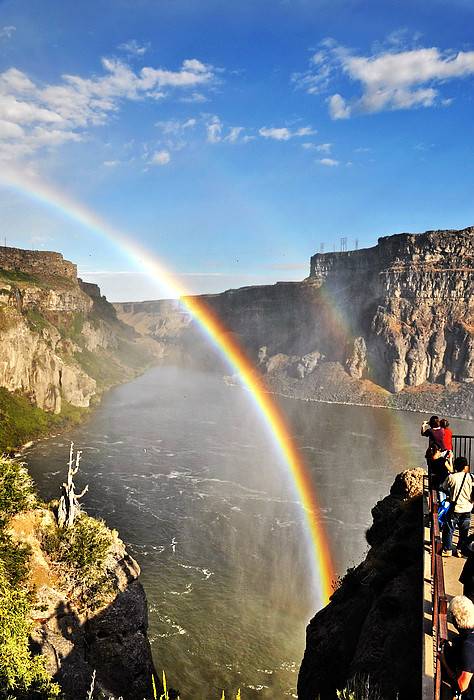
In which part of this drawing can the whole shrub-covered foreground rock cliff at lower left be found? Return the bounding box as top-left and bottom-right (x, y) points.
(0, 457), (160, 700)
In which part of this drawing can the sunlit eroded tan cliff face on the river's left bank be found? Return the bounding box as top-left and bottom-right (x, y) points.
(0, 248), (156, 413)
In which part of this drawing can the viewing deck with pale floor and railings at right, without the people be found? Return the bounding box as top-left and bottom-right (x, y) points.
(422, 436), (474, 700)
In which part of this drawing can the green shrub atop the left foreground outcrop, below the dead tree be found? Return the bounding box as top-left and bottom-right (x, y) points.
(43, 513), (117, 606)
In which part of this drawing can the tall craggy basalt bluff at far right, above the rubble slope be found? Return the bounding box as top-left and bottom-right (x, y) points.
(310, 228), (474, 392)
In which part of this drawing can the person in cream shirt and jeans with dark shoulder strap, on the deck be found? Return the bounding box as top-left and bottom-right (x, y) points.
(441, 457), (473, 557)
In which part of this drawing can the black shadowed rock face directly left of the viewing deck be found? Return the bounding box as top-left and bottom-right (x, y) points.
(298, 468), (424, 700)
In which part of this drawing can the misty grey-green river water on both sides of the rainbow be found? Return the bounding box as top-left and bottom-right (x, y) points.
(27, 368), (474, 700)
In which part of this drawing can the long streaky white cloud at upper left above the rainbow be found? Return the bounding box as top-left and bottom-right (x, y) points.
(0, 56), (215, 160)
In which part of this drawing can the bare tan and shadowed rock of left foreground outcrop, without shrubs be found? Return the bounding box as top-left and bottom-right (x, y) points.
(9, 508), (155, 700)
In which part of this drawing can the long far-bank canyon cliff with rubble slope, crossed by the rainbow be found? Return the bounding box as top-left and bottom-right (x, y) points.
(116, 228), (474, 415)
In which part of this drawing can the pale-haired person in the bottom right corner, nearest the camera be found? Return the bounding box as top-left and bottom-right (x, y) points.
(441, 595), (474, 700)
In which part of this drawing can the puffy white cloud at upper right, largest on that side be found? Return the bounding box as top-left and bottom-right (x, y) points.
(292, 39), (474, 119)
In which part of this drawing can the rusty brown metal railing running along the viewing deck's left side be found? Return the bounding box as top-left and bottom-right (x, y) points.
(429, 488), (448, 700)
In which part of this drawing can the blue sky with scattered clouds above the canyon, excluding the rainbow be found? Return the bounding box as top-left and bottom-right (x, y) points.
(0, 0), (474, 300)
